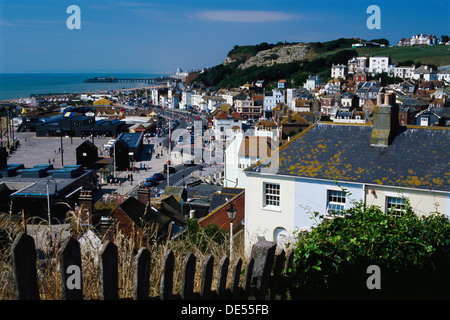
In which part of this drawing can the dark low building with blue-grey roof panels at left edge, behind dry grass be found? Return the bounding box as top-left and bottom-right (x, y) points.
(0, 156), (98, 223)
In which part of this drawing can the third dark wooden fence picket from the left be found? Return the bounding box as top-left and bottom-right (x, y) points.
(99, 240), (119, 300)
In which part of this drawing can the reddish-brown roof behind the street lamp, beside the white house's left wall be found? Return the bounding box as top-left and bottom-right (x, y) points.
(199, 191), (245, 231)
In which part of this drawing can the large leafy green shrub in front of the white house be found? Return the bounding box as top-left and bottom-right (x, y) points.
(291, 203), (450, 299)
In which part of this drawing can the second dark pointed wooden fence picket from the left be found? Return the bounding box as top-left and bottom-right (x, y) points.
(58, 237), (83, 300)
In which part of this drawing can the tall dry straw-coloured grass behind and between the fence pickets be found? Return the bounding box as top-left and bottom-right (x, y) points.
(0, 214), (246, 300)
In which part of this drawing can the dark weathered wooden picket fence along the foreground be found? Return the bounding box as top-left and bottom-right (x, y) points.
(11, 233), (292, 300)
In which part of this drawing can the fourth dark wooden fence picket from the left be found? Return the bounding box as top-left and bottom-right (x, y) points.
(133, 248), (151, 300)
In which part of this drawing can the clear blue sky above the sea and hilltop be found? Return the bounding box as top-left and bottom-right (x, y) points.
(0, 0), (450, 73)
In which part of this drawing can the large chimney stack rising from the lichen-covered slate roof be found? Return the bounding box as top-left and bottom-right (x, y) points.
(370, 93), (399, 147)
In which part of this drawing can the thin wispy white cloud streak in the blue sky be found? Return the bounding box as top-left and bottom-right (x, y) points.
(194, 10), (299, 23)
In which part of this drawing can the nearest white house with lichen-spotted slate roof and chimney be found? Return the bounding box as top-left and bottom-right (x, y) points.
(245, 94), (450, 254)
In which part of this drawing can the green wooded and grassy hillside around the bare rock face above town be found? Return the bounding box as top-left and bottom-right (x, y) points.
(196, 38), (450, 88)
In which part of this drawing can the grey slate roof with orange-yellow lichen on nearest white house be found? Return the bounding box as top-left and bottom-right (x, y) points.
(245, 123), (450, 192)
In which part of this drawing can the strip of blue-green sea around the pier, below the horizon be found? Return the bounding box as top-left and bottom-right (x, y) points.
(0, 73), (167, 100)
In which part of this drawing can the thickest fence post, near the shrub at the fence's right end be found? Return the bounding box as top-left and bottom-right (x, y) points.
(252, 241), (276, 300)
